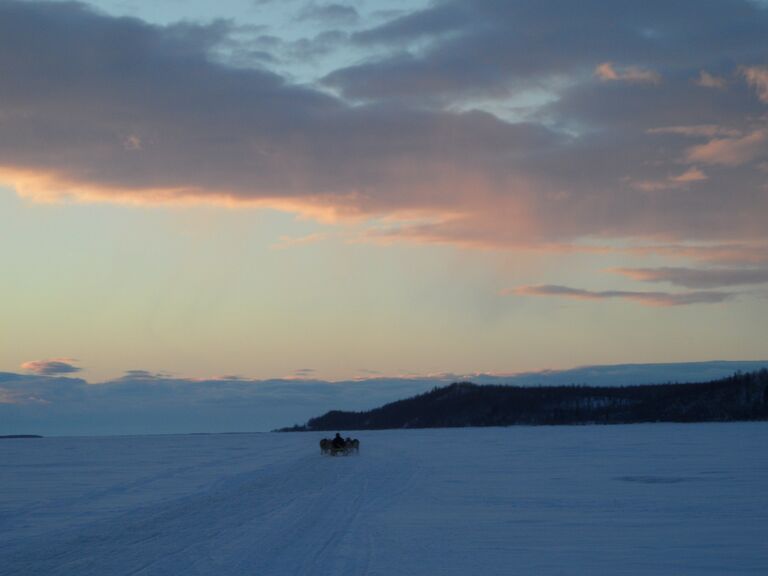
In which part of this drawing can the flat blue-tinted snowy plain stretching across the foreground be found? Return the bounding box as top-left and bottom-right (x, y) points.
(0, 423), (768, 576)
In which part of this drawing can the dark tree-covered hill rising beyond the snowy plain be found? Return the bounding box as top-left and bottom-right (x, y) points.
(284, 369), (768, 431)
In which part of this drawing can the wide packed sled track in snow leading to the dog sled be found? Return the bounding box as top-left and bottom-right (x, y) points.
(0, 436), (420, 576)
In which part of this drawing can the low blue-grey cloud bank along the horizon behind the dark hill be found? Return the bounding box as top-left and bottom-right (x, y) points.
(0, 362), (768, 435)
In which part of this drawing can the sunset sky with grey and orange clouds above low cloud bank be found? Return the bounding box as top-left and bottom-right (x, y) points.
(0, 0), (768, 418)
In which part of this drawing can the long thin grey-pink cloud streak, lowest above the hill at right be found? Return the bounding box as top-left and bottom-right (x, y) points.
(505, 284), (735, 306)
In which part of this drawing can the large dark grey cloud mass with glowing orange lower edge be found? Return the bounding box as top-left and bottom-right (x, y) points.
(0, 0), (768, 254)
